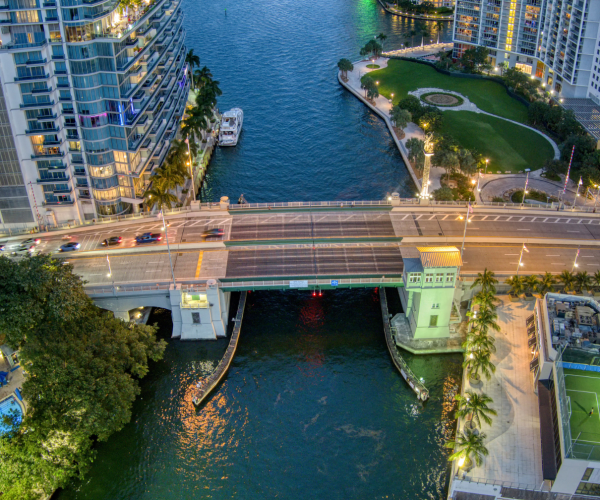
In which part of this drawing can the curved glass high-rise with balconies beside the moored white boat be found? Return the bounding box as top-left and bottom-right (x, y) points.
(0, 0), (189, 224)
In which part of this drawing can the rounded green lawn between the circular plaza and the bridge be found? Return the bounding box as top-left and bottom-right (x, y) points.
(441, 110), (554, 172)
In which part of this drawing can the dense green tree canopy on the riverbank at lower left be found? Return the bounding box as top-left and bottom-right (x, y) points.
(0, 254), (166, 500)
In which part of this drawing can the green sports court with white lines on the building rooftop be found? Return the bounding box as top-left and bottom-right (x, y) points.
(564, 369), (600, 460)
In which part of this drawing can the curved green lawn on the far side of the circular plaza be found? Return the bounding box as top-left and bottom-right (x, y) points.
(369, 59), (527, 122)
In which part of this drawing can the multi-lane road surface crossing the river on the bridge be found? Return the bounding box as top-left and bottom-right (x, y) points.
(7, 208), (600, 285)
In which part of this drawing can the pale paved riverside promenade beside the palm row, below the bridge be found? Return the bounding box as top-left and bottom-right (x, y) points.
(459, 295), (543, 488)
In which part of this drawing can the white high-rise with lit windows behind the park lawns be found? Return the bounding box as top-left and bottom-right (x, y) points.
(454, 0), (600, 98)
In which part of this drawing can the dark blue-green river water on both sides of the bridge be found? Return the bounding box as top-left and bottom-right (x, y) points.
(55, 0), (461, 500)
